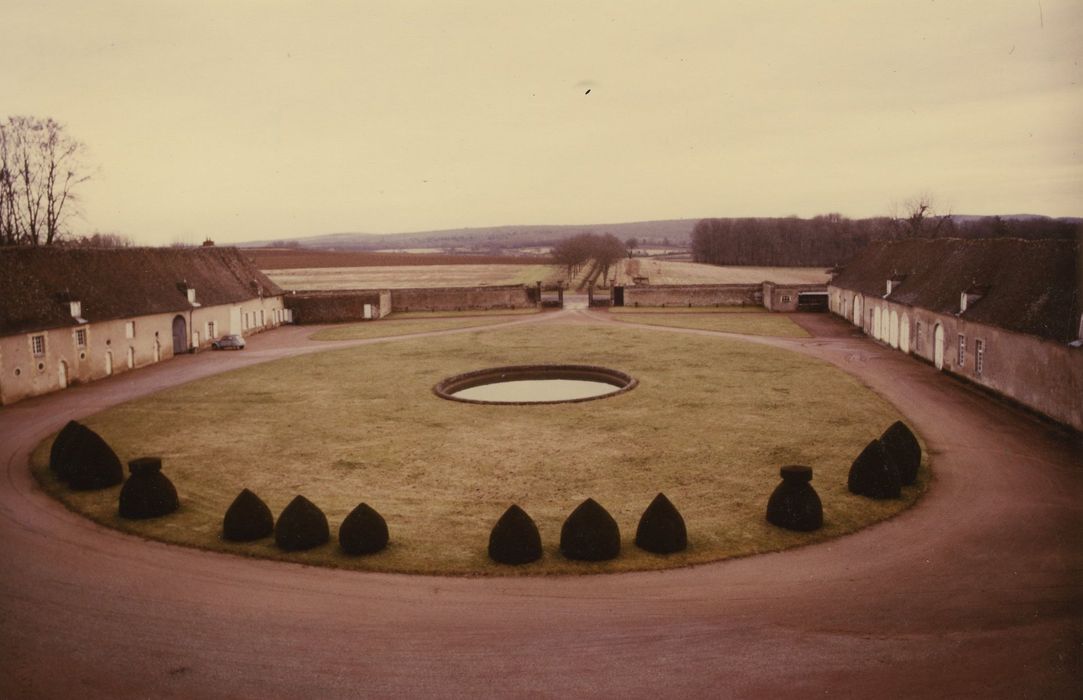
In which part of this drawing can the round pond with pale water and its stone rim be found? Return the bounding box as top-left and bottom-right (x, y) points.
(432, 364), (638, 405)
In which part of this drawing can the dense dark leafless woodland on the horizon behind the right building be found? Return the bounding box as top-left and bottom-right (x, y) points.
(692, 215), (1083, 267)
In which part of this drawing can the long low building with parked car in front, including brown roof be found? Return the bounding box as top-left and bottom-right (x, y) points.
(0, 246), (289, 404)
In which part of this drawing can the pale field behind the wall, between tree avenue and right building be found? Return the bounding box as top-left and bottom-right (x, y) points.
(610, 258), (831, 285)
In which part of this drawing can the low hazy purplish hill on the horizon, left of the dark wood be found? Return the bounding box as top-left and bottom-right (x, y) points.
(236, 219), (699, 251)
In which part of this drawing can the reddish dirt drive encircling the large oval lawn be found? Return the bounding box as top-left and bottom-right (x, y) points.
(0, 310), (1083, 698)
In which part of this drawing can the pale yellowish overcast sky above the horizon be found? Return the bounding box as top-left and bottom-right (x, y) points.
(0, 0), (1083, 245)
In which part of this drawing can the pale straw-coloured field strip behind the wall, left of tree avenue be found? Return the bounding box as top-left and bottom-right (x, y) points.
(265, 264), (563, 289)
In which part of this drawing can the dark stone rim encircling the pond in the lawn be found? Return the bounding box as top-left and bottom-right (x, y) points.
(432, 364), (639, 406)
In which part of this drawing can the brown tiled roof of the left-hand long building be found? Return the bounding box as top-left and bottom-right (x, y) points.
(0, 246), (282, 335)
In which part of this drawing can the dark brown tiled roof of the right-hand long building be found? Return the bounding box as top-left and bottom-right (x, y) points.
(831, 238), (1081, 342)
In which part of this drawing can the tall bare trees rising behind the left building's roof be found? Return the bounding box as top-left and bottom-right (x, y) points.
(0, 116), (90, 246)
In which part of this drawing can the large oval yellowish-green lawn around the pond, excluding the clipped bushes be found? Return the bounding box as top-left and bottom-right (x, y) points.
(32, 324), (929, 574)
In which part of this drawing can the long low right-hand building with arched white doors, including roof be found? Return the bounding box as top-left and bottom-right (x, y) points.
(828, 238), (1083, 430)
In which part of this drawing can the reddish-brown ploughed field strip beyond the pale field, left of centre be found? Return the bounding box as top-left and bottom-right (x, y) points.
(245, 248), (548, 270)
